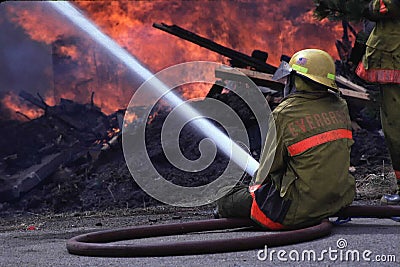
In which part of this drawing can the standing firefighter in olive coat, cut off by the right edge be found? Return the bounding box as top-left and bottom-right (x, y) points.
(356, 0), (400, 204)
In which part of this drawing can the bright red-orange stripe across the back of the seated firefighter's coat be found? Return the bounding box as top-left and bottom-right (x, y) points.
(288, 129), (353, 156)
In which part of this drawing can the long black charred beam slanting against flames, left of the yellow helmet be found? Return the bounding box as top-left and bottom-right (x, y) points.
(153, 23), (276, 73)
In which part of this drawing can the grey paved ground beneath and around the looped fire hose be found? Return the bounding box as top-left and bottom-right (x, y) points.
(0, 208), (400, 266)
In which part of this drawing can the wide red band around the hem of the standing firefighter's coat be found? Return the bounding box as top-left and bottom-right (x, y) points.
(356, 62), (400, 84)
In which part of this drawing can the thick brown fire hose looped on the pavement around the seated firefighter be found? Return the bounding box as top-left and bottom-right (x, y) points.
(67, 206), (400, 257)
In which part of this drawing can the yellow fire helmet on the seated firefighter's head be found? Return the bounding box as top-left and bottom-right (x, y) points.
(289, 49), (338, 91)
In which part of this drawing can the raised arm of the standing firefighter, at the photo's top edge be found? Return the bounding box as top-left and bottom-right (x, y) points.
(365, 0), (400, 21)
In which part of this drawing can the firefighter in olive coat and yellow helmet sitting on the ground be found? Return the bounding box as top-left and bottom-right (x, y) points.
(217, 49), (355, 230)
